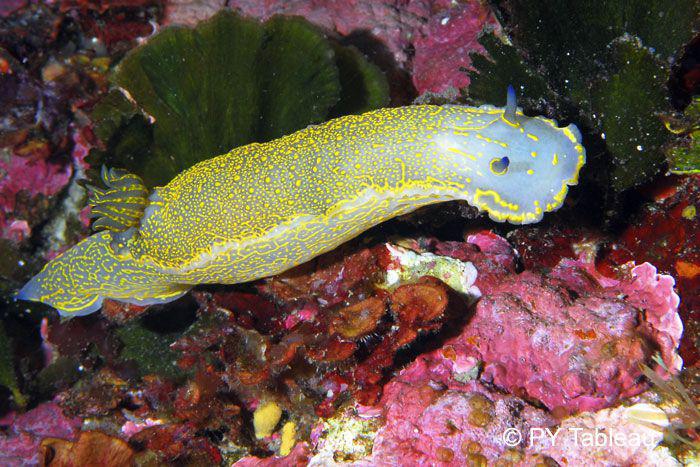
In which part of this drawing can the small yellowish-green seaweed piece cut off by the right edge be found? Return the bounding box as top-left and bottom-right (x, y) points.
(666, 97), (700, 175)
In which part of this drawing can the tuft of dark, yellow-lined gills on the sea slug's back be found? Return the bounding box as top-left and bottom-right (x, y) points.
(88, 166), (148, 232)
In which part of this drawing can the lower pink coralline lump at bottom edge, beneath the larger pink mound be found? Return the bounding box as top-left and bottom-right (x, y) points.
(369, 364), (556, 465)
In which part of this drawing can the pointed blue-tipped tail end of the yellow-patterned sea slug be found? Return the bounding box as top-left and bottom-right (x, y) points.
(17, 232), (191, 317)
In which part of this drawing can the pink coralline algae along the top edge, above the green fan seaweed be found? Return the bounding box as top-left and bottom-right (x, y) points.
(165, 0), (499, 94)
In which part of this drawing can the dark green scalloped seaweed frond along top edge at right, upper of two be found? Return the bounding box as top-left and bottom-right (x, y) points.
(502, 0), (698, 90)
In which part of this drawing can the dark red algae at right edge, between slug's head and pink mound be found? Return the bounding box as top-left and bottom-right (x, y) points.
(508, 175), (700, 366)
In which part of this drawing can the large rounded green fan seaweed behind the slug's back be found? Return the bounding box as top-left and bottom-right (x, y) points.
(91, 11), (388, 186)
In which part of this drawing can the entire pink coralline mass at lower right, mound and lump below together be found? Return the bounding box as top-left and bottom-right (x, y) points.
(360, 241), (682, 465)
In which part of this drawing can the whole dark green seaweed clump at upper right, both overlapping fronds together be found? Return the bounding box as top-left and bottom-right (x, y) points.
(468, 0), (698, 193)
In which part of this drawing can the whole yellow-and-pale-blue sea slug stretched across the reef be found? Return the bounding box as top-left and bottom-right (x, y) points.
(18, 89), (585, 316)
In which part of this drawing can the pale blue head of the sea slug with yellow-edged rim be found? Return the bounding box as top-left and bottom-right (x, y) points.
(441, 94), (586, 224)
